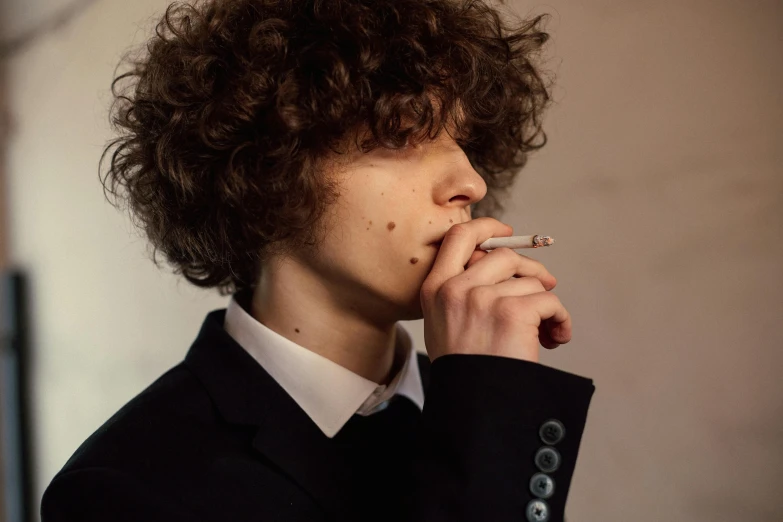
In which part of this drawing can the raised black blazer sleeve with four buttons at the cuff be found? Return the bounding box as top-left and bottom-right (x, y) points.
(413, 354), (595, 522)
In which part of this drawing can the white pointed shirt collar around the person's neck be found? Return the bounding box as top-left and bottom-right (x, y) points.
(224, 297), (424, 438)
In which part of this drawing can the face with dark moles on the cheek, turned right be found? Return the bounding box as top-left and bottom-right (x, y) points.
(290, 126), (487, 322)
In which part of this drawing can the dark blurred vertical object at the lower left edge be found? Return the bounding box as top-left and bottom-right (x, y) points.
(0, 272), (33, 522)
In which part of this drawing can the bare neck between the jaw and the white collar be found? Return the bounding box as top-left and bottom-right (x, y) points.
(248, 255), (397, 384)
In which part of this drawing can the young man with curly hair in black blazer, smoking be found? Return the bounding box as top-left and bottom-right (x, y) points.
(42, 0), (594, 522)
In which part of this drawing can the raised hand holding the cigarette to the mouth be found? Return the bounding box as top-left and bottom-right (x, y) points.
(420, 217), (571, 362)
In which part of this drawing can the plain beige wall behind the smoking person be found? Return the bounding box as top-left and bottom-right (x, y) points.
(1, 0), (783, 522)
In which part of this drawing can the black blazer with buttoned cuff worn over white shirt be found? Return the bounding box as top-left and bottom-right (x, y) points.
(41, 309), (595, 522)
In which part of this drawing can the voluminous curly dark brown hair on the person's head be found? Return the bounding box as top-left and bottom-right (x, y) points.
(99, 0), (550, 295)
